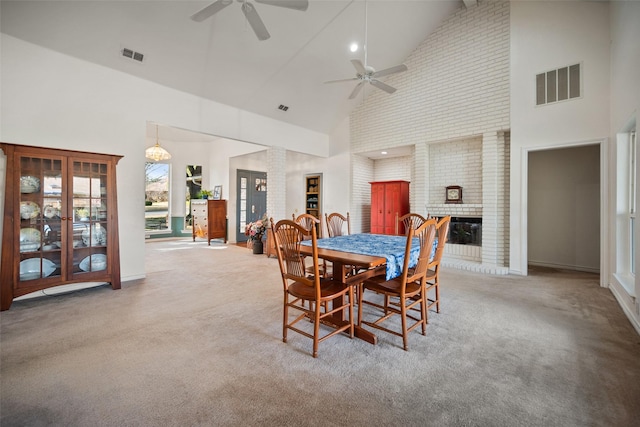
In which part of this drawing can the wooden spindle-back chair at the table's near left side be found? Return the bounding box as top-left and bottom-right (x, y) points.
(271, 218), (354, 357)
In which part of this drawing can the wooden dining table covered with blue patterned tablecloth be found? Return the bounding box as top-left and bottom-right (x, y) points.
(300, 233), (417, 344)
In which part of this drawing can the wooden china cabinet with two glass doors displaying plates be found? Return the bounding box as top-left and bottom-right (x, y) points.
(0, 143), (122, 310)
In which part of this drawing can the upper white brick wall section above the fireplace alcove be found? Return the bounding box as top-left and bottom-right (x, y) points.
(350, 0), (509, 153)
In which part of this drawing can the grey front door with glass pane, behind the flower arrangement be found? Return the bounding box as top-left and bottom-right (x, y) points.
(236, 169), (267, 242)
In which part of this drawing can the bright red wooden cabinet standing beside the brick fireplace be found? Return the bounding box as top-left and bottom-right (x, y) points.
(370, 181), (409, 234)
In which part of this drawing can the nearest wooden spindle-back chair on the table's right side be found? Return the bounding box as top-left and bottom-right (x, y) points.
(358, 219), (436, 350)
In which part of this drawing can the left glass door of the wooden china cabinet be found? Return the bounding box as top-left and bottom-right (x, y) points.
(16, 156), (65, 285)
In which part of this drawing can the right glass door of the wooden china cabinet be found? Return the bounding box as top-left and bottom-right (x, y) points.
(67, 160), (108, 275)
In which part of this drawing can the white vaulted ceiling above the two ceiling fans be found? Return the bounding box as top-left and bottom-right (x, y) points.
(0, 0), (474, 133)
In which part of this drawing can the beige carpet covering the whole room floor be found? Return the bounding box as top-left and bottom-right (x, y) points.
(0, 239), (640, 427)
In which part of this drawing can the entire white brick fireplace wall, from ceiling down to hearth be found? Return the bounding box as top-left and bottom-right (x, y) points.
(350, 0), (510, 273)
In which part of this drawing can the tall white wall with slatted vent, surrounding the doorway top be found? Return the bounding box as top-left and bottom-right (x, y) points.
(510, 2), (610, 274)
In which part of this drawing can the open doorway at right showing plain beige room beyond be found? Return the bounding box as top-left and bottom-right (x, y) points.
(527, 144), (601, 273)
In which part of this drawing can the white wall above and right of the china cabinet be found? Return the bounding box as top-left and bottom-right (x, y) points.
(0, 34), (329, 280)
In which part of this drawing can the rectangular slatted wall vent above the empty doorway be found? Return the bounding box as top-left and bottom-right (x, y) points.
(536, 64), (582, 105)
